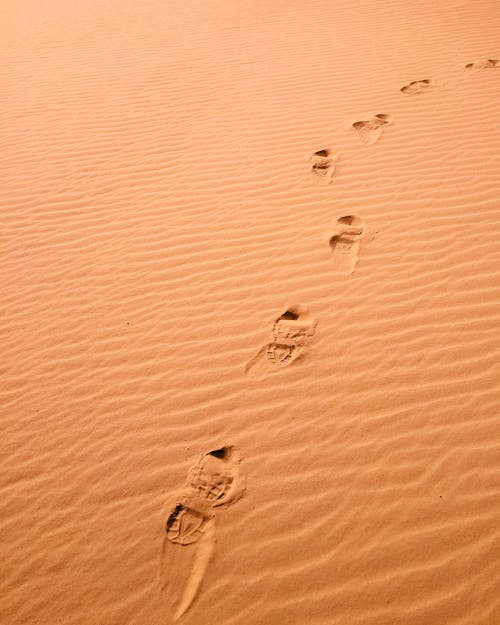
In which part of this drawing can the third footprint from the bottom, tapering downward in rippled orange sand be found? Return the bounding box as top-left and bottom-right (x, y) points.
(327, 215), (366, 275)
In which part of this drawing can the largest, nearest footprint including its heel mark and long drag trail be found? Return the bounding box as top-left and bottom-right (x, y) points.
(160, 446), (245, 619)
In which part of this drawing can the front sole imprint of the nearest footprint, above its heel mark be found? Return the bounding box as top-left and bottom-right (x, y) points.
(188, 446), (244, 507)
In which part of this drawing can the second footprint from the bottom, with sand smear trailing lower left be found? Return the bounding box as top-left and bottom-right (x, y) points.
(245, 306), (317, 375)
